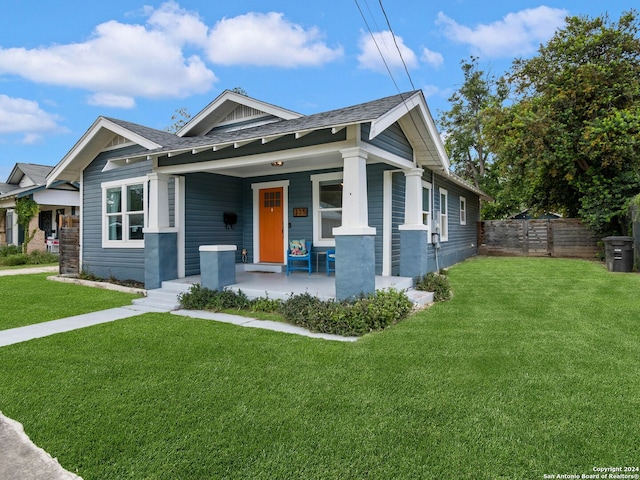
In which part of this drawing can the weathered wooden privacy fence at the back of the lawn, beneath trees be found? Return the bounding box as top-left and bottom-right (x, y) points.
(478, 218), (601, 259)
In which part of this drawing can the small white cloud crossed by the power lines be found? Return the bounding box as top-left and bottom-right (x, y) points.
(358, 30), (418, 72)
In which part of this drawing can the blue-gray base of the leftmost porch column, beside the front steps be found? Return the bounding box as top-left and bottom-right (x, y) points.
(144, 232), (178, 290)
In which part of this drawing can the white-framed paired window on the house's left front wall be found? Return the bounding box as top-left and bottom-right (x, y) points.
(102, 177), (147, 248)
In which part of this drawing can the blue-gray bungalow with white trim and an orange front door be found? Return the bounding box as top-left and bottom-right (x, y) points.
(48, 91), (484, 298)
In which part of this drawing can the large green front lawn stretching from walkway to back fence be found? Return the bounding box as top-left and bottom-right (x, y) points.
(0, 258), (640, 480)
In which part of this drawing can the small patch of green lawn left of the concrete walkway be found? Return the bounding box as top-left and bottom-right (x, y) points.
(0, 273), (137, 330)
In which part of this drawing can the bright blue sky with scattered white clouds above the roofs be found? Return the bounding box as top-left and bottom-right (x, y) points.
(0, 0), (631, 181)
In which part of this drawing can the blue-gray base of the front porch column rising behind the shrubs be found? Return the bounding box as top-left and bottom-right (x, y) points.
(336, 235), (376, 300)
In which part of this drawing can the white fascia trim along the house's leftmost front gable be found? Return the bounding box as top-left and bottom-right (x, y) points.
(47, 117), (161, 187)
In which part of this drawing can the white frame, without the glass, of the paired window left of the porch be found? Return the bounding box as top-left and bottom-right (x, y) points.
(100, 177), (149, 248)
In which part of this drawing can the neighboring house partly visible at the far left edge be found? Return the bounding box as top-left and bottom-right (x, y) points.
(0, 163), (80, 250)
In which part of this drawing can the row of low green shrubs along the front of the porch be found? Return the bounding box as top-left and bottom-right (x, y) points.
(179, 284), (412, 336)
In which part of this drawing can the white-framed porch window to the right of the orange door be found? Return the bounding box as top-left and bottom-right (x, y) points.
(311, 172), (342, 247)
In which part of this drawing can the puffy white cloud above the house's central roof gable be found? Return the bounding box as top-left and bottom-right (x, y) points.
(207, 12), (344, 67)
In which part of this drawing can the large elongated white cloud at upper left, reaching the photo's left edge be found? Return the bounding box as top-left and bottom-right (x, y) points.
(0, 17), (216, 98)
